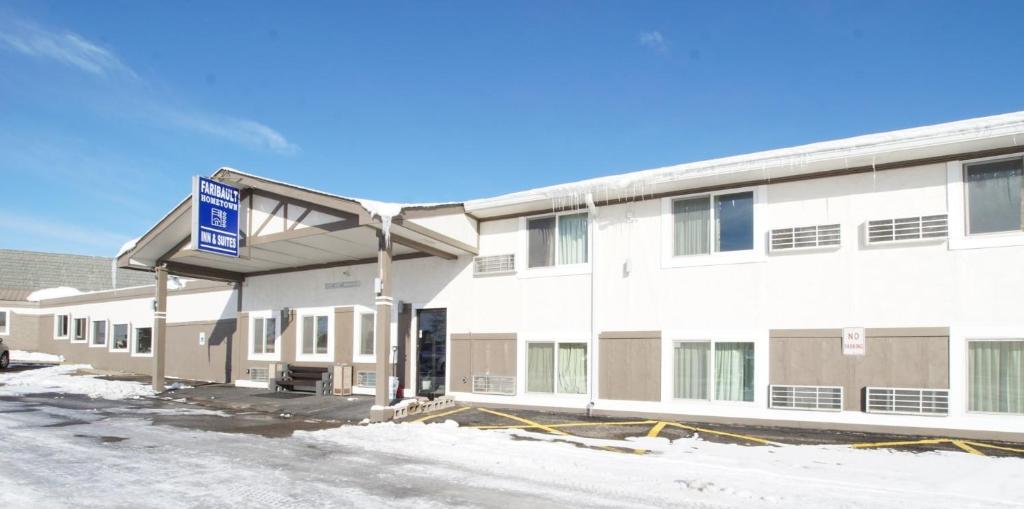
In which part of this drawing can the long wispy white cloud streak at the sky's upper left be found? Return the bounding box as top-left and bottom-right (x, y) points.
(0, 17), (300, 155)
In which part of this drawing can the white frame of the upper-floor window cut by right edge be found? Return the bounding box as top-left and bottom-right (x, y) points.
(946, 152), (1024, 250)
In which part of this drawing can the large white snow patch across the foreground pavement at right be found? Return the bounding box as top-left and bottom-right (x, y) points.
(296, 421), (1024, 509)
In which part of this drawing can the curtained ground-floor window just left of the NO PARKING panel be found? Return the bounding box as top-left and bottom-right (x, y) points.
(673, 341), (754, 401)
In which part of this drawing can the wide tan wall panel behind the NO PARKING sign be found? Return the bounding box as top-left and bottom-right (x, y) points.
(769, 336), (949, 412)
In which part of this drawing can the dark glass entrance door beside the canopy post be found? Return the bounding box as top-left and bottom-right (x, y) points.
(416, 309), (447, 399)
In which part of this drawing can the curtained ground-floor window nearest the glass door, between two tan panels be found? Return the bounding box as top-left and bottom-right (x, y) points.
(526, 343), (587, 394)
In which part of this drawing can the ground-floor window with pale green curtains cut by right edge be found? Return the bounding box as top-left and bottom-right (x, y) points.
(968, 340), (1024, 414)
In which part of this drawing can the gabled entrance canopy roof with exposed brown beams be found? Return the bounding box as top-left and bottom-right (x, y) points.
(118, 168), (477, 282)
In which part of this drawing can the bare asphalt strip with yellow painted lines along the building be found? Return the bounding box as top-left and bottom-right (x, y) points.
(402, 406), (1024, 458)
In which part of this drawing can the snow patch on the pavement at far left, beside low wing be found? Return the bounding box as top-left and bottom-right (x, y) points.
(0, 365), (153, 399)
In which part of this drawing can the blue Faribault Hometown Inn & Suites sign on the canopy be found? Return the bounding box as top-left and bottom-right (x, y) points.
(193, 176), (239, 257)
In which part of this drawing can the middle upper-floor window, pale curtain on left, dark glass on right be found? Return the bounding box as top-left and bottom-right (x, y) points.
(672, 190), (754, 256)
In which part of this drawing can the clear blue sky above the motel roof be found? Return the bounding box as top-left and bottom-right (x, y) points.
(0, 1), (1024, 256)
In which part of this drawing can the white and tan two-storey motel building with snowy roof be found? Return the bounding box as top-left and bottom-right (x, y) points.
(0, 112), (1024, 439)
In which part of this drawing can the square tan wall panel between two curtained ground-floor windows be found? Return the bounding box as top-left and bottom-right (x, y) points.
(598, 333), (662, 401)
